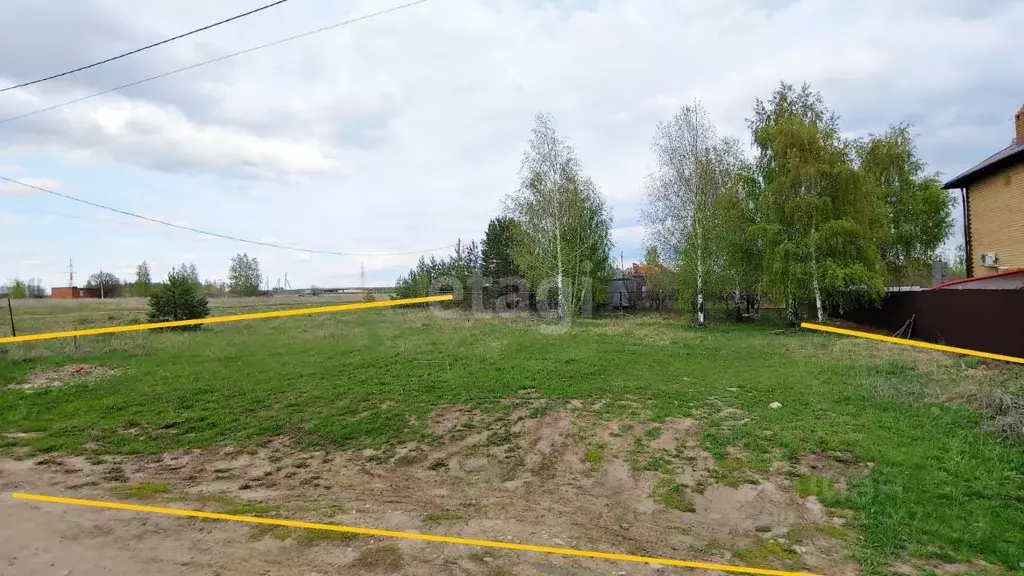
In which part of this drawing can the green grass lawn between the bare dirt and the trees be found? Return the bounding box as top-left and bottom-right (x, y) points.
(0, 310), (1024, 573)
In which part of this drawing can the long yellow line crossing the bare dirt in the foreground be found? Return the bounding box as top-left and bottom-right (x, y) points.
(11, 492), (821, 576)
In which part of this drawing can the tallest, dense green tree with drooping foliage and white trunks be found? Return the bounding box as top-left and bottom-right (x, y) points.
(750, 82), (885, 323)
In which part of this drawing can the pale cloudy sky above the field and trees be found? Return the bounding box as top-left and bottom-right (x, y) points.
(0, 0), (1024, 288)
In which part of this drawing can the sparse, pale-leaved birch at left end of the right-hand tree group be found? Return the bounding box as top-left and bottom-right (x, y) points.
(641, 102), (742, 326)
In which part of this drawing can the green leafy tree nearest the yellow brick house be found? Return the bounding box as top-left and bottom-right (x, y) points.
(857, 124), (953, 284)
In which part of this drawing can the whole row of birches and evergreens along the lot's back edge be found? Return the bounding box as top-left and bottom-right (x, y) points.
(396, 82), (953, 324)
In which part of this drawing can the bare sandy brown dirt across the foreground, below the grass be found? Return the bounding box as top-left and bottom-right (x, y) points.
(0, 400), (854, 575)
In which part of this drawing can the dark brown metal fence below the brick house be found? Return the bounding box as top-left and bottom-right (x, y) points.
(838, 290), (1024, 357)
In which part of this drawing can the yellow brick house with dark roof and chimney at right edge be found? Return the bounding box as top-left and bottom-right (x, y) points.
(942, 107), (1024, 278)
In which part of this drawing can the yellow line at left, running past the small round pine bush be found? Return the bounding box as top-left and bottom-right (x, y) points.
(0, 294), (453, 344)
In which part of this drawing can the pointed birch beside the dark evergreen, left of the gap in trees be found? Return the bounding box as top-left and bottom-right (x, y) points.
(506, 114), (611, 319)
